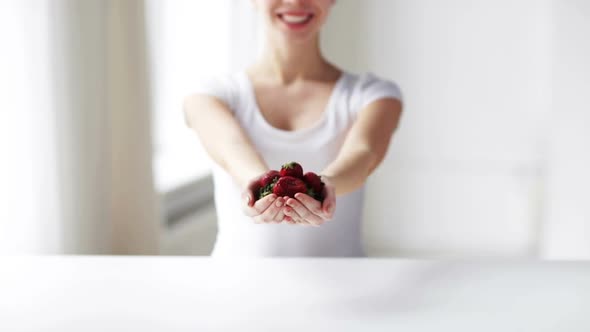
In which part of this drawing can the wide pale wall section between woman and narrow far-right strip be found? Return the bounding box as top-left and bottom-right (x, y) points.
(324, 0), (552, 257)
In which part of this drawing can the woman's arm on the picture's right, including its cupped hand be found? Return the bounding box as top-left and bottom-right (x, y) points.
(285, 98), (402, 226)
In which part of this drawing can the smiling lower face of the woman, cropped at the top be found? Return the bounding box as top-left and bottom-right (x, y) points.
(253, 0), (334, 42)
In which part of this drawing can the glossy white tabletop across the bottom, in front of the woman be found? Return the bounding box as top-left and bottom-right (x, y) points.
(0, 256), (590, 332)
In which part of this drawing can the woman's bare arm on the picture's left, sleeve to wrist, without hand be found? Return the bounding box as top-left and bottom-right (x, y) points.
(183, 94), (268, 189)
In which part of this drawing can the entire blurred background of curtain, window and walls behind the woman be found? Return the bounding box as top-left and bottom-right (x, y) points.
(0, 0), (590, 259)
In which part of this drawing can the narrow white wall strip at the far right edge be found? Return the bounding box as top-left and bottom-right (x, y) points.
(542, 0), (590, 259)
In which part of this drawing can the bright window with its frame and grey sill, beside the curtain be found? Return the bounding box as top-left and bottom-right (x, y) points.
(146, 0), (260, 224)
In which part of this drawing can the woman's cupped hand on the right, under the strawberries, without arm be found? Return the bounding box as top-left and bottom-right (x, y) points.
(284, 175), (336, 227)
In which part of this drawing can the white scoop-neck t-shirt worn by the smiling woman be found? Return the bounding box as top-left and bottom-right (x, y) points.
(195, 71), (402, 257)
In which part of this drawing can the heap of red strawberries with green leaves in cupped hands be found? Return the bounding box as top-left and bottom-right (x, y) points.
(258, 162), (324, 202)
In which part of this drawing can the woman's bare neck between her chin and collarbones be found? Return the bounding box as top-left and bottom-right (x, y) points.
(257, 36), (331, 84)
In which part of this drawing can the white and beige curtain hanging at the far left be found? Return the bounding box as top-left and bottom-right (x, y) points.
(0, 0), (160, 254)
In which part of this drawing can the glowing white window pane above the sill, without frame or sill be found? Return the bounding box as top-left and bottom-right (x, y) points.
(146, 0), (231, 193)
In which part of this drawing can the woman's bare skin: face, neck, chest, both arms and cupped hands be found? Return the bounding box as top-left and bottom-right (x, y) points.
(184, 0), (402, 227)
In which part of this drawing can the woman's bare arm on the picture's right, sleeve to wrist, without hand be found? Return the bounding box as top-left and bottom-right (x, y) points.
(322, 98), (402, 196)
